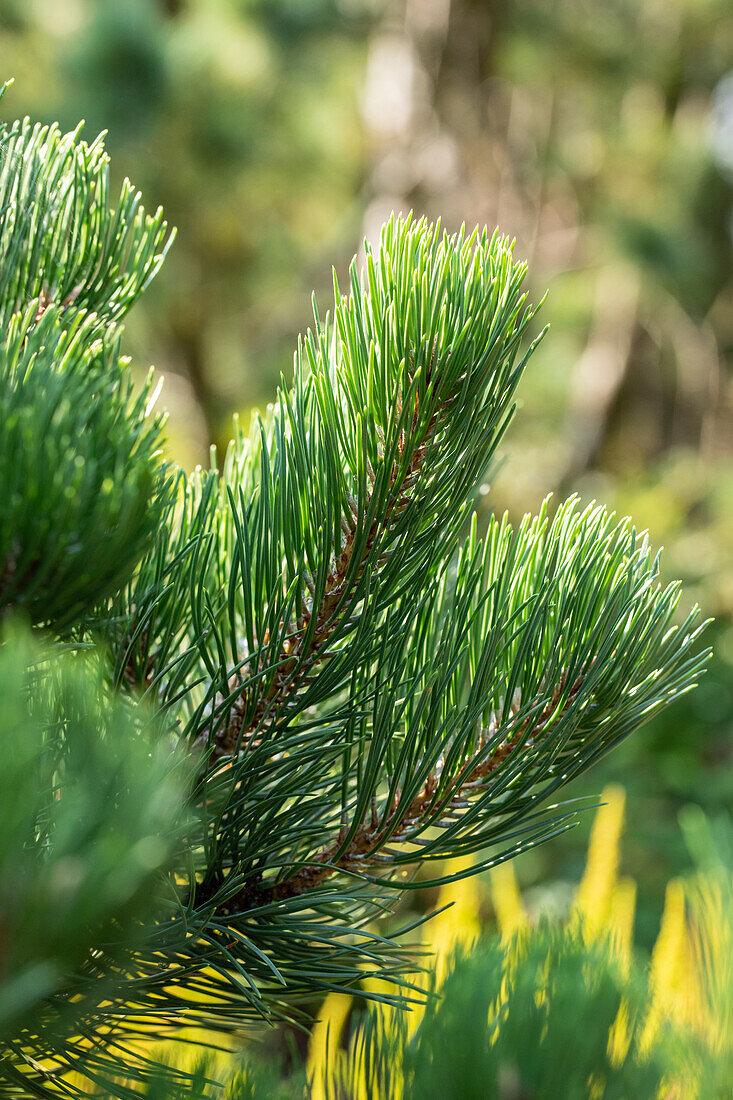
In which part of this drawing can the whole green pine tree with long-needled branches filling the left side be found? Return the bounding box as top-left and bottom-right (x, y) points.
(0, 88), (705, 1097)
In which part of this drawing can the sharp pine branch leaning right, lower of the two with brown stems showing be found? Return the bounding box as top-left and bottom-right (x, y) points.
(191, 502), (704, 928)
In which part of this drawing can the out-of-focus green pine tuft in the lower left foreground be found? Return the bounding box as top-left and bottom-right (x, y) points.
(0, 624), (189, 1042)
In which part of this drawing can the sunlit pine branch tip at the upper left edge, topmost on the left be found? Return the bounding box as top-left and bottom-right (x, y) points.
(0, 119), (173, 330)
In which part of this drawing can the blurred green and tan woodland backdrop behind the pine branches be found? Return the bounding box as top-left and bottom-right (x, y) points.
(0, 0), (733, 944)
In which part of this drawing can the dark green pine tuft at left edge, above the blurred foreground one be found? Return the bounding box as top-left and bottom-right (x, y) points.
(0, 303), (169, 629)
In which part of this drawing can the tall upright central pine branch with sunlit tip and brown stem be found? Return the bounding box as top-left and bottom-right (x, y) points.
(191, 212), (539, 761)
